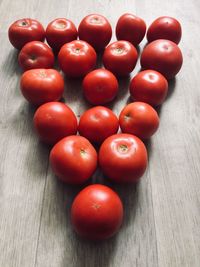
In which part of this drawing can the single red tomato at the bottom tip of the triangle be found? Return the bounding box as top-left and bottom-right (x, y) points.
(71, 184), (123, 240)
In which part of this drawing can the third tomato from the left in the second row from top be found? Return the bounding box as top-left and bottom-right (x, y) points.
(103, 41), (138, 76)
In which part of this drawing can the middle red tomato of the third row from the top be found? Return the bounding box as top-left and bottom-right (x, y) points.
(82, 69), (118, 105)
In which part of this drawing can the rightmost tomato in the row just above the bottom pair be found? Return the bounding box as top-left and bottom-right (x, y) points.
(119, 102), (159, 139)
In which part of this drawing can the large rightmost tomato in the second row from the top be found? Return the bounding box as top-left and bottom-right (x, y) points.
(140, 39), (183, 79)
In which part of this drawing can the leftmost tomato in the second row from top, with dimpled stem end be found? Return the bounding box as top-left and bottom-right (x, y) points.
(18, 41), (54, 70)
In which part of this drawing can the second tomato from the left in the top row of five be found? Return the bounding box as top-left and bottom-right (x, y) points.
(46, 18), (78, 52)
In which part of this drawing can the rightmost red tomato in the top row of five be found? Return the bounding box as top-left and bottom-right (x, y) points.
(147, 16), (182, 44)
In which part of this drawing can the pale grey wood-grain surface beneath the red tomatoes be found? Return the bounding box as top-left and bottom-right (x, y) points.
(0, 0), (200, 267)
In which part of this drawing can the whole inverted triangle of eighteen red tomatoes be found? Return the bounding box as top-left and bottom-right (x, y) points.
(8, 14), (183, 242)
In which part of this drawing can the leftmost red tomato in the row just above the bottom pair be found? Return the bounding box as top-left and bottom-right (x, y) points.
(33, 102), (77, 145)
